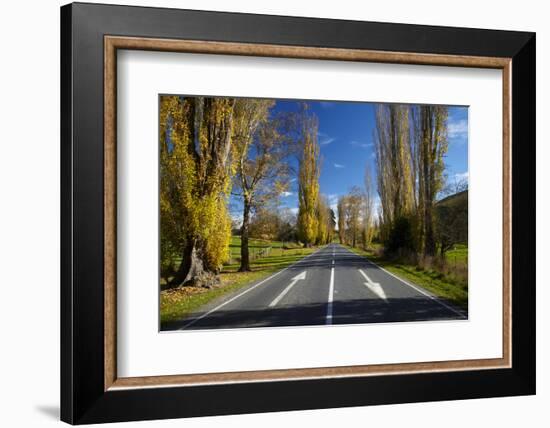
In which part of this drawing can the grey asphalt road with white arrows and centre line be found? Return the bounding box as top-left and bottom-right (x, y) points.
(163, 244), (466, 330)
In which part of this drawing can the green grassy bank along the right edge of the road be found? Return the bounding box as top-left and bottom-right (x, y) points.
(347, 246), (468, 310)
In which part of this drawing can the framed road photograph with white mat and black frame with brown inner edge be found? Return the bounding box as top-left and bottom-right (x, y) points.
(61, 3), (535, 424)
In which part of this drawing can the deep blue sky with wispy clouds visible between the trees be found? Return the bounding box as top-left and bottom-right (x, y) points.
(232, 100), (468, 221)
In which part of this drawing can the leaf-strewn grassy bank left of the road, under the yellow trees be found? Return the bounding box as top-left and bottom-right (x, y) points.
(160, 241), (316, 323)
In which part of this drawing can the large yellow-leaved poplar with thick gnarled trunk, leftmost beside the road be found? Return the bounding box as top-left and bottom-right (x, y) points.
(160, 96), (235, 287)
